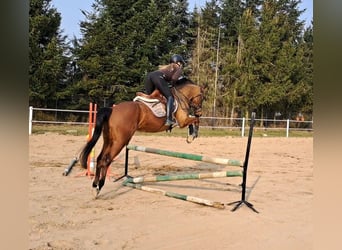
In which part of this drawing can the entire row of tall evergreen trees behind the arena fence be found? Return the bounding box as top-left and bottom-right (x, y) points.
(29, 0), (313, 118)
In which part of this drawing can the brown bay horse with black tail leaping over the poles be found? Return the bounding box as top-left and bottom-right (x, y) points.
(79, 78), (204, 197)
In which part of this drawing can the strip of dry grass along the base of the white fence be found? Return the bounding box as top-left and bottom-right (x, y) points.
(32, 124), (313, 137)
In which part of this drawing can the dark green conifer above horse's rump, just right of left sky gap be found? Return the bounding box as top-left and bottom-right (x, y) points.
(74, 0), (148, 106)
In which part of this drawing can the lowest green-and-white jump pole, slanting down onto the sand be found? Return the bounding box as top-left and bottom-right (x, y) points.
(123, 181), (225, 209)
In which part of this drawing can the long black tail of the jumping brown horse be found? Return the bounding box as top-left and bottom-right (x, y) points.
(80, 107), (112, 168)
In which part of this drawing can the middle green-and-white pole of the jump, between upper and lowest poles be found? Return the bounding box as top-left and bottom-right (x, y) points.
(126, 171), (242, 183)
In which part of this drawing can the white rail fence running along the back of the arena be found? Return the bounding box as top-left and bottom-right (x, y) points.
(29, 106), (313, 137)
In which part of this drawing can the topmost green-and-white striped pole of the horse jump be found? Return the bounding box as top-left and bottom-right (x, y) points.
(127, 145), (243, 167)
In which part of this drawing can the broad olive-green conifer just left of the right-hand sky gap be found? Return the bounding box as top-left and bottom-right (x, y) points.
(243, 0), (305, 120)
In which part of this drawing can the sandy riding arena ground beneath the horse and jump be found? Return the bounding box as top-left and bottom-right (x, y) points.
(29, 134), (313, 250)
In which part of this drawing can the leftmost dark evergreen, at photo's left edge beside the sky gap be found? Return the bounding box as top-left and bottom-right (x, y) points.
(29, 0), (68, 107)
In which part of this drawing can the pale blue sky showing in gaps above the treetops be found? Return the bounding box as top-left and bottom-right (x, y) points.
(51, 0), (313, 39)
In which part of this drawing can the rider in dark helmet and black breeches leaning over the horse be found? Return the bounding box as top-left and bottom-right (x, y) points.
(145, 54), (185, 126)
